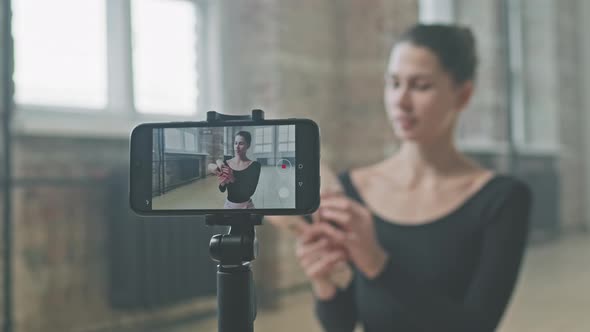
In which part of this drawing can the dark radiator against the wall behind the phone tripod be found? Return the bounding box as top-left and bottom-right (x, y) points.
(107, 169), (226, 308)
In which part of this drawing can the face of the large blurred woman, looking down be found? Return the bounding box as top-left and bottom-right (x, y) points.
(385, 42), (472, 142)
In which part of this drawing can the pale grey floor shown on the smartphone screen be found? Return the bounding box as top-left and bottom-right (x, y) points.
(152, 167), (295, 209)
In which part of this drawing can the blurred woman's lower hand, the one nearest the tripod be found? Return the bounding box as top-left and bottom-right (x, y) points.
(295, 222), (347, 300)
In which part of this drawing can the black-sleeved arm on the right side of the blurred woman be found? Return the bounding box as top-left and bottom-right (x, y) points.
(373, 183), (531, 332)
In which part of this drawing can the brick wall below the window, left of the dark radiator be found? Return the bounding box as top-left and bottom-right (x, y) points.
(13, 137), (224, 332)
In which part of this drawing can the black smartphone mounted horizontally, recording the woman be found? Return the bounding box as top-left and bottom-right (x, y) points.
(129, 119), (320, 215)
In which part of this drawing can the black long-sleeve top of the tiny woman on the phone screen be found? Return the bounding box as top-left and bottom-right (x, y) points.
(219, 161), (260, 203)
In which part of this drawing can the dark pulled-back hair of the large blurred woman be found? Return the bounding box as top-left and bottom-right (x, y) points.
(398, 24), (477, 84)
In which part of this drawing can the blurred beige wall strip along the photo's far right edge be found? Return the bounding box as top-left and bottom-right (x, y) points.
(554, 1), (590, 231)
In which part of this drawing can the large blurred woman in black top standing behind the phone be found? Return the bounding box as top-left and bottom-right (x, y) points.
(297, 25), (531, 332)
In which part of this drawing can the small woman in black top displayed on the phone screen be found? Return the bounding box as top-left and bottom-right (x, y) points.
(215, 131), (260, 209)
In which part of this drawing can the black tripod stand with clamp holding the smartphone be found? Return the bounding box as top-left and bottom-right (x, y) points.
(206, 110), (264, 332)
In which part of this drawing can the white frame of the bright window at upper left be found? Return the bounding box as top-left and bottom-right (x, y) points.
(13, 0), (221, 138)
